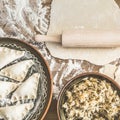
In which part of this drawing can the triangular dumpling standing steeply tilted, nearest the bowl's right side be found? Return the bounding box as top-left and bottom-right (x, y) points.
(11, 73), (40, 102)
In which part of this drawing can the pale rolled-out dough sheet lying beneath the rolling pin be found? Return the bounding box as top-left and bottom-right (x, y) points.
(47, 0), (120, 65)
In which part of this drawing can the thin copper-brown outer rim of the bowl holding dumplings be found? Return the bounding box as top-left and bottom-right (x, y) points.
(0, 37), (53, 120)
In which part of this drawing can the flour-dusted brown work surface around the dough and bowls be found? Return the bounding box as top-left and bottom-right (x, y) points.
(0, 0), (120, 98)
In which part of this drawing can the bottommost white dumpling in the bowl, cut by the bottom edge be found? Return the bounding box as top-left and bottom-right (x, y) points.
(0, 102), (34, 120)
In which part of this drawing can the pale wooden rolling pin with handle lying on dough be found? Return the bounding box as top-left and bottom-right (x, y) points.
(35, 29), (120, 48)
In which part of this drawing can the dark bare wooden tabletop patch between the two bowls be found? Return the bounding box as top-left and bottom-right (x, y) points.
(44, 100), (58, 120)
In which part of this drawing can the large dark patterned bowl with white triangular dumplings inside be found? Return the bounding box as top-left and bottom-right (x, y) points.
(0, 38), (52, 120)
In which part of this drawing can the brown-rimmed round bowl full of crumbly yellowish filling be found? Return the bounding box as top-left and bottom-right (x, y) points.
(57, 72), (120, 120)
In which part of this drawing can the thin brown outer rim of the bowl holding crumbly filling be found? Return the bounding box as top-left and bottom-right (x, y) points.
(57, 72), (120, 120)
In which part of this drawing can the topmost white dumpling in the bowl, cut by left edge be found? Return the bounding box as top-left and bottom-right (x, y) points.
(0, 47), (25, 69)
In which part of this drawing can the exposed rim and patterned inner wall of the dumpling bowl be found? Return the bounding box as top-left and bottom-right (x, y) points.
(0, 38), (52, 120)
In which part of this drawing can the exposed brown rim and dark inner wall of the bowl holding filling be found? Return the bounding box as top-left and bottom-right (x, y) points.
(57, 72), (120, 120)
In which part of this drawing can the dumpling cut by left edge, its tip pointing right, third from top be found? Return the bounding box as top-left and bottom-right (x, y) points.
(0, 81), (20, 100)
